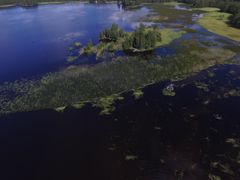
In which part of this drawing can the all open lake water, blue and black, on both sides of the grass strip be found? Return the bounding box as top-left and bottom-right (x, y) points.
(0, 3), (240, 180)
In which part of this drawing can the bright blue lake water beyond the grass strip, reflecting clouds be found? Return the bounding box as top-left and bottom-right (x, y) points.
(0, 3), (148, 82)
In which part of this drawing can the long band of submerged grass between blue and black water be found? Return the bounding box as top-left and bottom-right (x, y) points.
(0, 42), (235, 114)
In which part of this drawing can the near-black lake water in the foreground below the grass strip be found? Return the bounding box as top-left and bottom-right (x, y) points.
(0, 66), (240, 180)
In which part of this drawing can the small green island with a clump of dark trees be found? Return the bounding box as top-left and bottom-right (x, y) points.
(80, 24), (185, 56)
